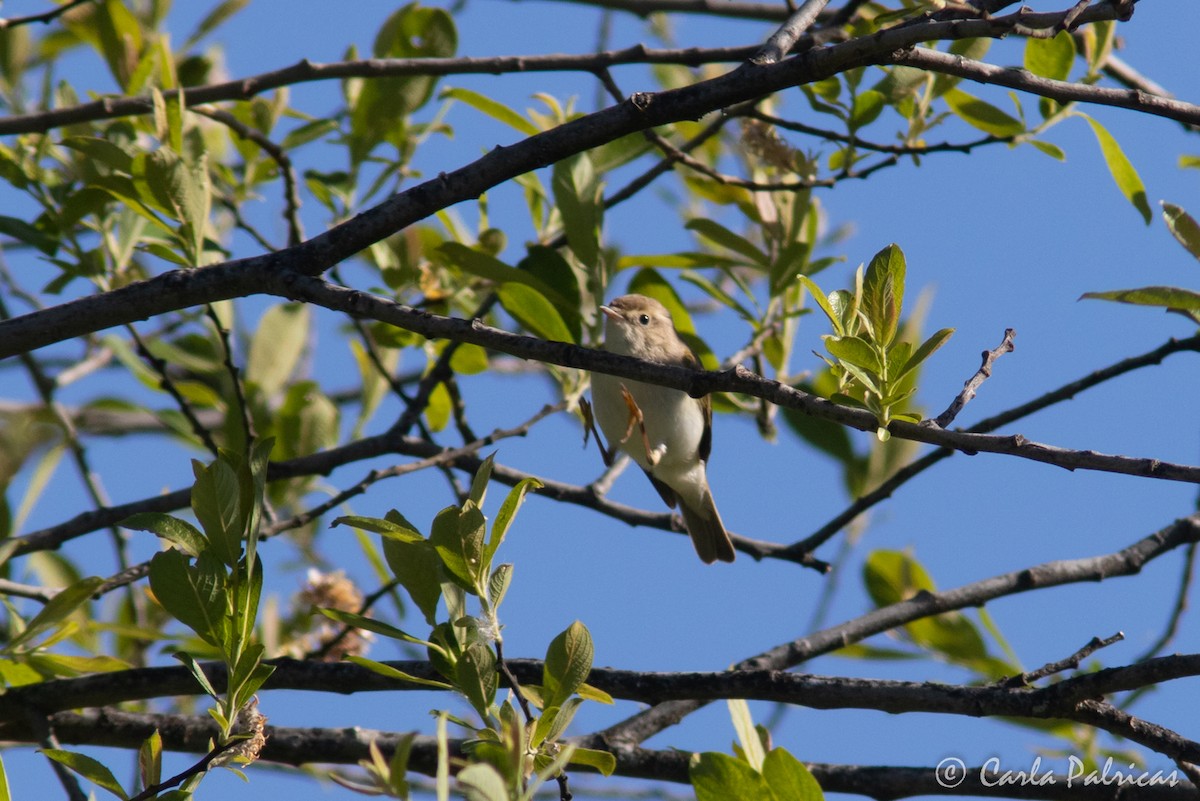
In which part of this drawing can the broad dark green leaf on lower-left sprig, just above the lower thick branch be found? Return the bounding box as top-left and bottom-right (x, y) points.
(150, 548), (228, 646)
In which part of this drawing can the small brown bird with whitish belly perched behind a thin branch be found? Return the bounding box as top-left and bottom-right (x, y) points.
(592, 295), (733, 564)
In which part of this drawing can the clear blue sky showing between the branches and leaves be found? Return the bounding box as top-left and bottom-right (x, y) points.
(5, 0), (1200, 800)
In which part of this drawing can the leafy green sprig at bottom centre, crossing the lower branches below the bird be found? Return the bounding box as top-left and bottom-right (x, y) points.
(320, 454), (616, 801)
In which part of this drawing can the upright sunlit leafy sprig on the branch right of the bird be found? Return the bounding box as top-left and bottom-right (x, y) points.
(799, 245), (954, 441)
